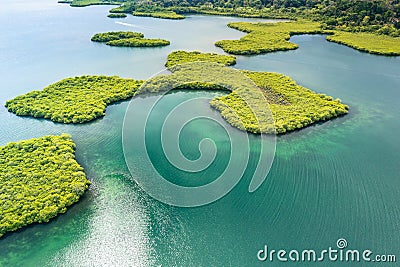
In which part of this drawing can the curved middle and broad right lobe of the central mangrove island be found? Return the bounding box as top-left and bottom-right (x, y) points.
(142, 62), (348, 134)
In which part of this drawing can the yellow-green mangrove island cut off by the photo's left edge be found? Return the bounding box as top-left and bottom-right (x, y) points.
(0, 134), (90, 236)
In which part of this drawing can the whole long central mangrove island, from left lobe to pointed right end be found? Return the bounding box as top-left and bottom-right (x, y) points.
(6, 51), (348, 134)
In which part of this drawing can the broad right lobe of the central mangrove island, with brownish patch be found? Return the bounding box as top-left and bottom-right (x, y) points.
(210, 71), (348, 134)
